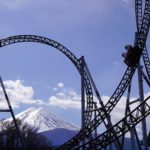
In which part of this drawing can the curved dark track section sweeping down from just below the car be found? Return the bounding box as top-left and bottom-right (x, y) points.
(58, 67), (135, 150)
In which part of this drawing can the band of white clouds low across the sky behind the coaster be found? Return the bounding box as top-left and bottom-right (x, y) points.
(0, 80), (150, 137)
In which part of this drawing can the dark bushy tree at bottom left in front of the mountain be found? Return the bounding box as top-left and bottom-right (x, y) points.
(0, 120), (53, 150)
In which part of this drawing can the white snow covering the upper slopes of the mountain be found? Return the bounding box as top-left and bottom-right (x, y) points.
(12, 107), (80, 132)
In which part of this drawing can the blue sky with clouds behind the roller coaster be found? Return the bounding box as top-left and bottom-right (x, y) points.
(0, 0), (147, 136)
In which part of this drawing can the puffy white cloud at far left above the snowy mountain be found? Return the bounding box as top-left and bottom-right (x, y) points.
(0, 80), (44, 108)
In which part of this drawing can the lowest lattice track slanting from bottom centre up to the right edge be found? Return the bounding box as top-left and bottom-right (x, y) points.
(78, 96), (150, 150)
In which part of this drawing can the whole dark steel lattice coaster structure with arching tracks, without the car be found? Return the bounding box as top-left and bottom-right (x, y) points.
(0, 0), (150, 150)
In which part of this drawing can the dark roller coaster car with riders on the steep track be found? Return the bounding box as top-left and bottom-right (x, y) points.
(122, 45), (142, 67)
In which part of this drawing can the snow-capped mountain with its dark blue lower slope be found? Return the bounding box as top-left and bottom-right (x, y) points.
(5, 107), (80, 146)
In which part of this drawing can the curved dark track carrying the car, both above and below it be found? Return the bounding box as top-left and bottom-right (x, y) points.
(58, 0), (150, 150)
